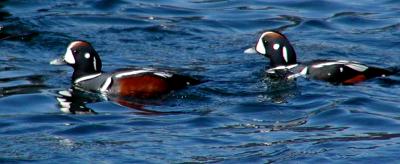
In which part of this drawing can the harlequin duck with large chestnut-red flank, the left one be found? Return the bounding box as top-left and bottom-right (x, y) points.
(50, 41), (201, 98)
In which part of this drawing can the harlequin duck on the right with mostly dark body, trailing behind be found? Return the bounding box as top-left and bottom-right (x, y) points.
(245, 31), (398, 85)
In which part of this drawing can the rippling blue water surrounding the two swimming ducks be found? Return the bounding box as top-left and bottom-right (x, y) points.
(0, 0), (400, 163)
